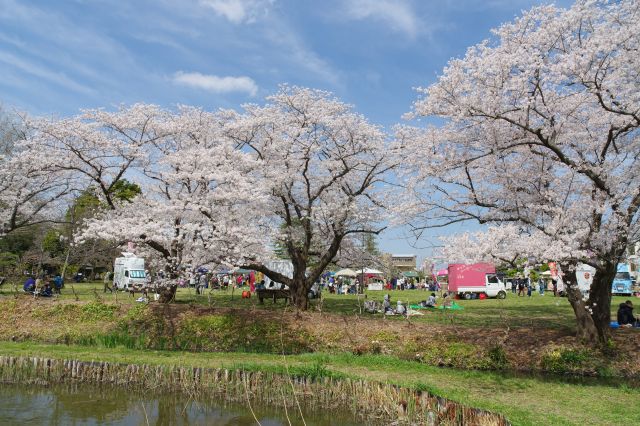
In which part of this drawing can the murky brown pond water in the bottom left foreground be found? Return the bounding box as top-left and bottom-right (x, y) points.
(0, 384), (361, 426)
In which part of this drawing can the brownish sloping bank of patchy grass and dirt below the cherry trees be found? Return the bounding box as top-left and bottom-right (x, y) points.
(0, 297), (640, 377)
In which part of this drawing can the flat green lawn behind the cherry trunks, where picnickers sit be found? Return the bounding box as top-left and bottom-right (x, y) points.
(0, 282), (628, 331)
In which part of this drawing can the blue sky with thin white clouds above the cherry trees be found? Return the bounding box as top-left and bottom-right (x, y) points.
(0, 0), (569, 264)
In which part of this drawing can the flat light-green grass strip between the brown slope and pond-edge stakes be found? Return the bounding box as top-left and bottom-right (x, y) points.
(0, 342), (640, 425)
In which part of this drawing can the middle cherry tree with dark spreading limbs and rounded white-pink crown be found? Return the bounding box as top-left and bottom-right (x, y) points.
(227, 86), (396, 309)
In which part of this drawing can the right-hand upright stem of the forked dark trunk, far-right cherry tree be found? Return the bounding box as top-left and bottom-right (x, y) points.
(587, 262), (618, 344)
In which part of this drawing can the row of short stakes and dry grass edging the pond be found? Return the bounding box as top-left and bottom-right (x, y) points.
(0, 356), (508, 426)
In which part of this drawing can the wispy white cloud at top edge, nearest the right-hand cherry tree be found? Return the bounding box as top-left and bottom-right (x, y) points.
(344, 0), (420, 38)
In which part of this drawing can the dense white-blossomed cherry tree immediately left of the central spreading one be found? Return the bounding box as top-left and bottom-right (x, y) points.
(77, 107), (267, 302)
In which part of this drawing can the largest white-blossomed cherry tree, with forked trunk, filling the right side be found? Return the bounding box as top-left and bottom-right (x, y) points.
(398, 0), (640, 342)
